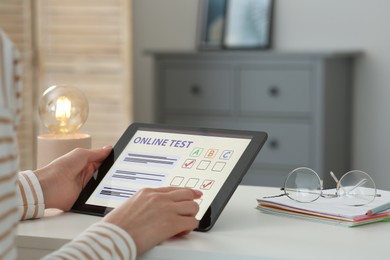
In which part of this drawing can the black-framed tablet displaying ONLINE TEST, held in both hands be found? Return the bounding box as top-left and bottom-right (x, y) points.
(72, 123), (267, 231)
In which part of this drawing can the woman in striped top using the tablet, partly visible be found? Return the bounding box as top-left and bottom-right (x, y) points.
(0, 27), (202, 259)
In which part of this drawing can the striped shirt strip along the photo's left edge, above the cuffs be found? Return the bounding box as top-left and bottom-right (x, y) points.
(0, 29), (21, 259)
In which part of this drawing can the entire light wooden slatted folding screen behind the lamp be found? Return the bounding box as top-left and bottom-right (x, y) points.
(0, 0), (132, 169)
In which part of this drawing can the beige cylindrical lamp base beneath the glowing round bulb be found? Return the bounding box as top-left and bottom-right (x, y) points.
(37, 134), (92, 168)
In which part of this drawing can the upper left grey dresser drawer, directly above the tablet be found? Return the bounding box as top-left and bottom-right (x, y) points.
(163, 68), (233, 114)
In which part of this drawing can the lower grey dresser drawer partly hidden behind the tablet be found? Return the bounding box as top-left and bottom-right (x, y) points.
(165, 116), (311, 168)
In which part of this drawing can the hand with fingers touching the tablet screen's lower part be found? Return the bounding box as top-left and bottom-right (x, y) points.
(103, 187), (202, 255)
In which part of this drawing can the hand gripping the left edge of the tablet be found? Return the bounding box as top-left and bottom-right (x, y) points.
(34, 146), (112, 211)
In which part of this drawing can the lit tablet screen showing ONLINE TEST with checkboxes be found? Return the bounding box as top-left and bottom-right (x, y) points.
(86, 130), (251, 220)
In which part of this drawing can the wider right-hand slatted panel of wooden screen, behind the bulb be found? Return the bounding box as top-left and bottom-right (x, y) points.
(36, 0), (132, 147)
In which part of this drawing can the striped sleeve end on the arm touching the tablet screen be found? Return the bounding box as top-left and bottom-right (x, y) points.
(44, 222), (137, 260)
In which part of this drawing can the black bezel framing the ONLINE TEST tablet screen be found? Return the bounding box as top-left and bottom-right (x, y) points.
(71, 123), (268, 231)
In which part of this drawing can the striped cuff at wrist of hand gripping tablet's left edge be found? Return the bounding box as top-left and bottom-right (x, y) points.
(16, 171), (45, 220)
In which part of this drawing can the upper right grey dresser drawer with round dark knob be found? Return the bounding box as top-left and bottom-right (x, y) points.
(238, 68), (313, 114)
